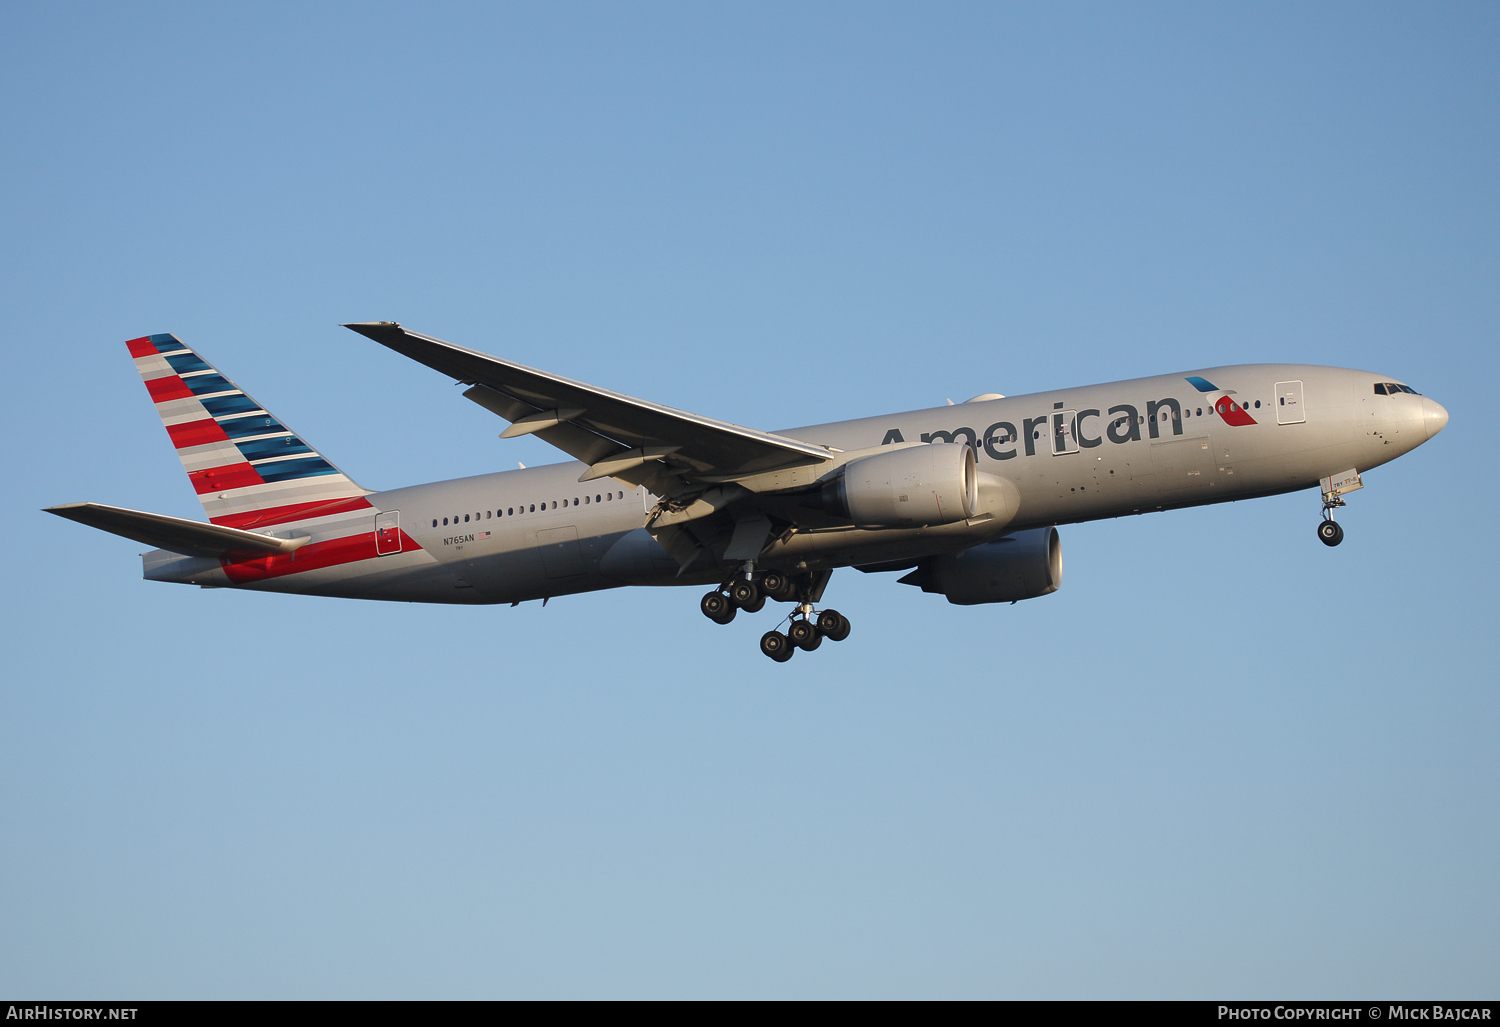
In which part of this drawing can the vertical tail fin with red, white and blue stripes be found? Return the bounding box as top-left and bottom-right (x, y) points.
(125, 334), (369, 528)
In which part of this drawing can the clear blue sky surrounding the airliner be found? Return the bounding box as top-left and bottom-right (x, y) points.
(0, 3), (1500, 999)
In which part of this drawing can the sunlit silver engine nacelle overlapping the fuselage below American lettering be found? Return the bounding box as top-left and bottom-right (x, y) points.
(822, 442), (980, 528)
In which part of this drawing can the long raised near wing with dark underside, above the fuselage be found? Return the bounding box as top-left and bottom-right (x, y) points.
(344, 321), (833, 495)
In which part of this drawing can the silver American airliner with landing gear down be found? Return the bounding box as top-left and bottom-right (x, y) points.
(48, 321), (1448, 663)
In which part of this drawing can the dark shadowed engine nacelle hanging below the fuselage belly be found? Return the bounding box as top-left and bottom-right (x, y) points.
(902, 528), (1062, 606)
